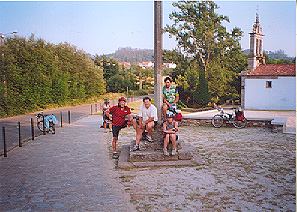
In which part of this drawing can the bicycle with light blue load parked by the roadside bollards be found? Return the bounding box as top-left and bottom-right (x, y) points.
(36, 111), (58, 134)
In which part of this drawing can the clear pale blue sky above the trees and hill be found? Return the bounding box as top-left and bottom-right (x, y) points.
(0, 0), (296, 57)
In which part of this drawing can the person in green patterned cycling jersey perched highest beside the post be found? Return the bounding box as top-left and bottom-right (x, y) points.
(163, 77), (179, 119)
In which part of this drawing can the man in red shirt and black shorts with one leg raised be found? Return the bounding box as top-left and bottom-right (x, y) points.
(106, 97), (133, 159)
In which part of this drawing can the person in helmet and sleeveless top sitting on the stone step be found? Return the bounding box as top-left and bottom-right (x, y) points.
(163, 111), (178, 156)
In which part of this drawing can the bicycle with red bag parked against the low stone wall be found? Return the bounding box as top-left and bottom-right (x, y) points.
(211, 108), (247, 128)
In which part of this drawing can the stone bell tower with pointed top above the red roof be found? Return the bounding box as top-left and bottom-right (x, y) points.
(248, 13), (265, 72)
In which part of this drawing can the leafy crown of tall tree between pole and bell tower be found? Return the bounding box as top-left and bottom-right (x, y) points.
(165, 1), (242, 73)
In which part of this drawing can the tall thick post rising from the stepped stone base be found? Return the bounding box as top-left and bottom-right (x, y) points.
(154, 1), (163, 123)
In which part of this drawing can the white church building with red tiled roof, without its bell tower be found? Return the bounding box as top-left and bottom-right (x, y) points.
(244, 64), (296, 110)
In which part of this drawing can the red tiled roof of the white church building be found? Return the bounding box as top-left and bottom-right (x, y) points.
(249, 64), (296, 76)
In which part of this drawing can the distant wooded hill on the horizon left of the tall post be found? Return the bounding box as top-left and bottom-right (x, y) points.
(106, 47), (154, 63)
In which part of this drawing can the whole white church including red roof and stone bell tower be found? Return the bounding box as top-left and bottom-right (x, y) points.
(240, 14), (296, 110)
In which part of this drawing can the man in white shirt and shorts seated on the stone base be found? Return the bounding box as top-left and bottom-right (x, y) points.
(133, 97), (158, 151)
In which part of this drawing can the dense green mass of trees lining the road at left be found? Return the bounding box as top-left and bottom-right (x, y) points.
(0, 35), (105, 116)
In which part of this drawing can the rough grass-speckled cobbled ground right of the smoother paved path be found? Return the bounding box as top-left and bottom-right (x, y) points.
(118, 127), (296, 212)
